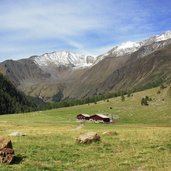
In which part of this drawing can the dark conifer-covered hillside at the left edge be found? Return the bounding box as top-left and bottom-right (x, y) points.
(0, 74), (36, 114)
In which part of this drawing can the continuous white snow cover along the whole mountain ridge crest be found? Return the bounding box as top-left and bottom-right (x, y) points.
(33, 31), (171, 69)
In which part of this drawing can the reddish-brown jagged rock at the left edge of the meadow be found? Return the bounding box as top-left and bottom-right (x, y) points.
(0, 138), (14, 164)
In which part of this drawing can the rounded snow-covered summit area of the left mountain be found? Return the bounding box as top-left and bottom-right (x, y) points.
(33, 51), (95, 68)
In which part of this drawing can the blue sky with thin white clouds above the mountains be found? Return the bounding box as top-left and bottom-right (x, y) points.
(0, 0), (171, 61)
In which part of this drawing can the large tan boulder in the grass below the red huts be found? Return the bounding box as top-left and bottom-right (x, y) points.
(76, 132), (100, 144)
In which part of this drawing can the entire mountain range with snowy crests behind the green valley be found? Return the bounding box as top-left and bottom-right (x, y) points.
(0, 31), (171, 101)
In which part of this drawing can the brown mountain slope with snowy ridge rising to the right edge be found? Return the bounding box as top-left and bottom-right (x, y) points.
(65, 31), (171, 98)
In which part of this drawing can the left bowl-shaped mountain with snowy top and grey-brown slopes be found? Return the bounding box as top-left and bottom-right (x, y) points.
(0, 51), (96, 101)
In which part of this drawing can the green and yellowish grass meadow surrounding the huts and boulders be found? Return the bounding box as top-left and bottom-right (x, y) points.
(0, 87), (171, 171)
